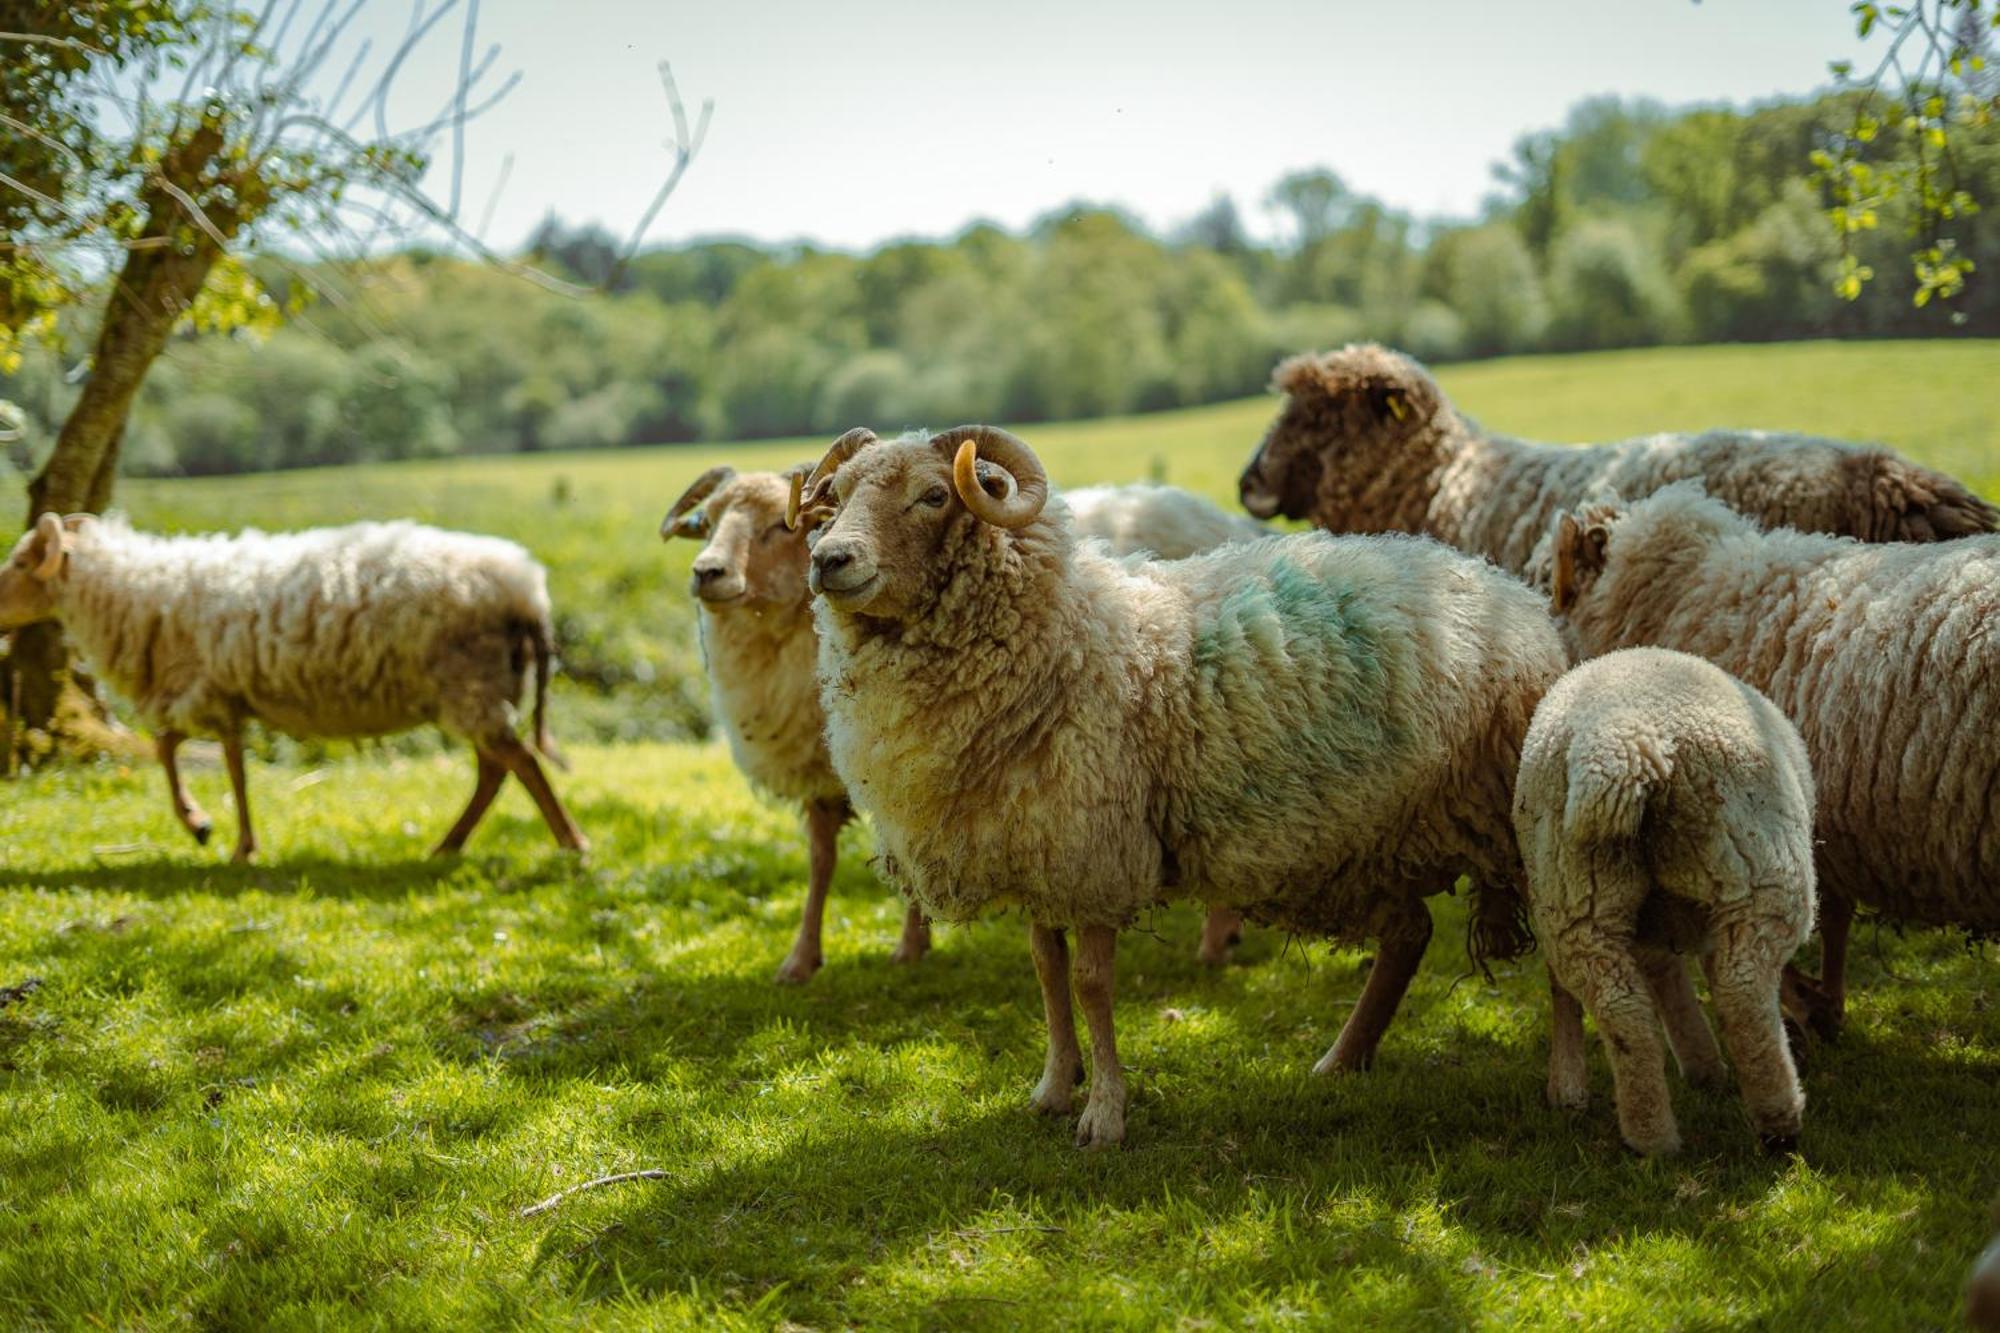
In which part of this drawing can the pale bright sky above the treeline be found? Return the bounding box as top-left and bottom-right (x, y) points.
(328, 0), (1860, 248)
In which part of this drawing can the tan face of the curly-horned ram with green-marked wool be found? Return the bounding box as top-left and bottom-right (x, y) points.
(812, 440), (970, 620)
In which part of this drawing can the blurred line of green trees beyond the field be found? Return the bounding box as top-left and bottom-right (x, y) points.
(0, 96), (2000, 472)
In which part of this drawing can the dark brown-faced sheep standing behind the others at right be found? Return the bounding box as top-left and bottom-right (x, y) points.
(1240, 344), (2000, 574)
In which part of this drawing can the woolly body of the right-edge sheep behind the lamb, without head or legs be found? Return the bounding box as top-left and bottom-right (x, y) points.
(1610, 532), (2000, 931)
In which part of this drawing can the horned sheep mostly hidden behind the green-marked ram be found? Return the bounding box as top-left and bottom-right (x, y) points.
(660, 462), (1264, 983)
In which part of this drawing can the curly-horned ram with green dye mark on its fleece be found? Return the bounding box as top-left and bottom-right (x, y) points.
(784, 426), (1564, 1147)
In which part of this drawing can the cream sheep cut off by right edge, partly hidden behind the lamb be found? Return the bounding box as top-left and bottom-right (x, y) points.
(1550, 482), (2000, 1033)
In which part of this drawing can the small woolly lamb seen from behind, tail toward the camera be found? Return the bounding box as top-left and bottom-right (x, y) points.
(1514, 648), (1814, 1155)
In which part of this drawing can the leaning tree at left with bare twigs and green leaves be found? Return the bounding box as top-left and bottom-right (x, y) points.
(0, 0), (708, 725)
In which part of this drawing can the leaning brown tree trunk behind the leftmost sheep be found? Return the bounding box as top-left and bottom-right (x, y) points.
(6, 226), (222, 729)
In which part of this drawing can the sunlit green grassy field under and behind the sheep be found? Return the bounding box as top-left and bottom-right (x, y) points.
(0, 344), (2000, 1329)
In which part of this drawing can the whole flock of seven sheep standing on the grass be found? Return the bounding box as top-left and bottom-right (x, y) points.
(0, 346), (2000, 1281)
